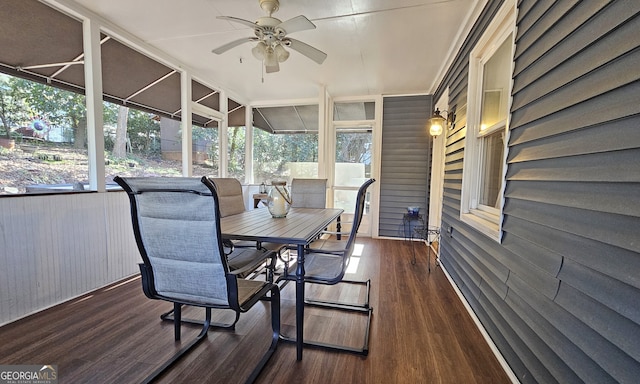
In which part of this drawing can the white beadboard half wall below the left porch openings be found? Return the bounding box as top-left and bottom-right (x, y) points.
(0, 192), (140, 326)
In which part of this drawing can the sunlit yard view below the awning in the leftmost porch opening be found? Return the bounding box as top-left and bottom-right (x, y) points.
(0, 74), (89, 195)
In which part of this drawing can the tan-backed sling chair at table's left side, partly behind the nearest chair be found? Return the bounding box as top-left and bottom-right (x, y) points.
(209, 177), (284, 281)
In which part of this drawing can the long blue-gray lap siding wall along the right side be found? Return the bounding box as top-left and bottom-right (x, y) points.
(435, 0), (640, 383)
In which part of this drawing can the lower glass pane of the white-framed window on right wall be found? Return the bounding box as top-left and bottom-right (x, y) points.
(479, 130), (504, 208)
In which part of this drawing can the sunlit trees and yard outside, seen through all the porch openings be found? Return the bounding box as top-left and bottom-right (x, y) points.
(0, 74), (371, 193)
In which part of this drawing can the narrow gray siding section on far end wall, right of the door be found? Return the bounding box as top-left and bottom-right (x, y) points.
(378, 95), (432, 237)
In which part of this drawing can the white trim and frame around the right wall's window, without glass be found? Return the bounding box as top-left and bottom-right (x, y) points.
(460, 0), (516, 242)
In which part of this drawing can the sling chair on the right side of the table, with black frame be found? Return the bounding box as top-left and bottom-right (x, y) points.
(277, 179), (375, 356)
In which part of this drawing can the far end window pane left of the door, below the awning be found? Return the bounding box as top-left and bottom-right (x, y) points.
(253, 129), (318, 184)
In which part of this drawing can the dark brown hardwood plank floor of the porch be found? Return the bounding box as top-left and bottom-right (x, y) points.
(0, 238), (510, 384)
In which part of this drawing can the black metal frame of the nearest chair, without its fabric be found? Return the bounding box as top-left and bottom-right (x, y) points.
(114, 176), (280, 383)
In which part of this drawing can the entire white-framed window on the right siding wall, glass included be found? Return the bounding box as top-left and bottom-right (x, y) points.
(461, 1), (515, 241)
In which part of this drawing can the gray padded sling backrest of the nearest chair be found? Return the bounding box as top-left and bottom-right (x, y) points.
(114, 177), (237, 308)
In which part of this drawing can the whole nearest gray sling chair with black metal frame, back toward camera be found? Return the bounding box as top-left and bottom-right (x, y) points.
(114, 177), (280, 382)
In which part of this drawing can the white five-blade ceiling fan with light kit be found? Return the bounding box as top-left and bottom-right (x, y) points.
(212, 0), (327, 73)
